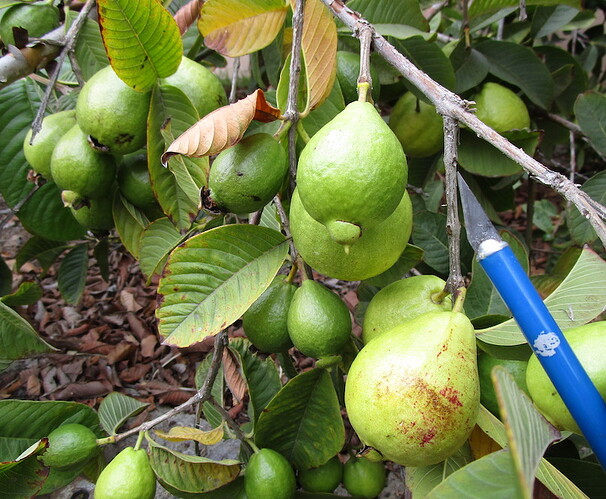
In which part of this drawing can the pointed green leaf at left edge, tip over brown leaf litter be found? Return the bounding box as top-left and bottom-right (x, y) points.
(0, 302), (55, 368)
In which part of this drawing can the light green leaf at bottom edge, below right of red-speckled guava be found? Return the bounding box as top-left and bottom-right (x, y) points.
(426, 449), (524, 499)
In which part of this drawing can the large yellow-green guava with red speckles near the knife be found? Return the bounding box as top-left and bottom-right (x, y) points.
(345, 312), (480, 466)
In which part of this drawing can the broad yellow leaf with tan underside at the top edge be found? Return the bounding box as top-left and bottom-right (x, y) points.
(198, 0), (287, 57)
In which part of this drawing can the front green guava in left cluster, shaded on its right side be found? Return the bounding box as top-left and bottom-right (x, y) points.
(51, 125), (116, 199)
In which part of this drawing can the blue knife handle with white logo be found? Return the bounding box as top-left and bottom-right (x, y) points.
(480, 246), (606, 468)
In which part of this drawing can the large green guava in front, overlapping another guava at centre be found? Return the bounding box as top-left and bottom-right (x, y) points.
(297, 102), (408, 246)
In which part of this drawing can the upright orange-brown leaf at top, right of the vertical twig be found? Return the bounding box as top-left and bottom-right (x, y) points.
(291, 0), (337, 113)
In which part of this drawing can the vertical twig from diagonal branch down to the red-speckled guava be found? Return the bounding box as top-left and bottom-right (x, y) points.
(444, 116), (465, 295)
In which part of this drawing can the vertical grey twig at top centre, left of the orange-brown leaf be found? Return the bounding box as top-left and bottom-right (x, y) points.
(284, 0), (305, 190)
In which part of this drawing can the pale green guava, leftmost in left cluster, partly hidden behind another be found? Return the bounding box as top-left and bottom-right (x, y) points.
(23, 110), (76, 181)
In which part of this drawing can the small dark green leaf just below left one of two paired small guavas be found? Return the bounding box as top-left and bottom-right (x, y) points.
(229, 338), (282, 423)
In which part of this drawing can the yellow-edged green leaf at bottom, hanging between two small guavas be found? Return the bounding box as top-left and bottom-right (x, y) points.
(148, 438), (240, 497)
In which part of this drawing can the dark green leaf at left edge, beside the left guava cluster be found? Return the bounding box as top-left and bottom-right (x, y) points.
(0, 78), (40, 207)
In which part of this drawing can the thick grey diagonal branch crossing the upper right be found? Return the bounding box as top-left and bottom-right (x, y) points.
(322, 0), (606, 247)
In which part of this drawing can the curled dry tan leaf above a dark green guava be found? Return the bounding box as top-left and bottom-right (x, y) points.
(162, 90), (280, 164)
